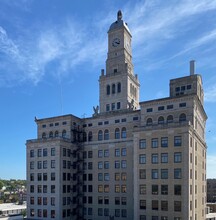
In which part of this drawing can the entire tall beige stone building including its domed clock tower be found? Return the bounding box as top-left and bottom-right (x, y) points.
(26, 11), (207, 220)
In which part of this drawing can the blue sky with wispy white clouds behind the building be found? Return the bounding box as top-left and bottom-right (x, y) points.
(0, 0), (216, 179)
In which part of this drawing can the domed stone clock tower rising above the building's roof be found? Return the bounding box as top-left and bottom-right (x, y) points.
(99, 11), (140, 113)
